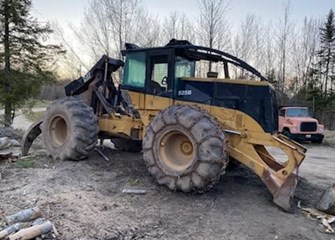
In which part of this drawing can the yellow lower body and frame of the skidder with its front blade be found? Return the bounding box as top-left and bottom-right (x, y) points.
(105, 89), (306, 210)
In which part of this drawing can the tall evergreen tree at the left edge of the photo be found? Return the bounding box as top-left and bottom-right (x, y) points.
(0, 0), (61, 126)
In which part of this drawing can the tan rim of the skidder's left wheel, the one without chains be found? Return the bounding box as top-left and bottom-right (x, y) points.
(49, 116), (67, 146)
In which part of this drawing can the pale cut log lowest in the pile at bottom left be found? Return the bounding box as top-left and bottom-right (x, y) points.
(8, 221), (53, 240)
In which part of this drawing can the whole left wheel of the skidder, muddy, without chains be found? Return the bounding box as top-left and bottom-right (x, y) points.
(41, 97), (99, 160)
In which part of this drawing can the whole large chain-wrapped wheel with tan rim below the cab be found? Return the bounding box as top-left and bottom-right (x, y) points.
(143, 105), (228, 192)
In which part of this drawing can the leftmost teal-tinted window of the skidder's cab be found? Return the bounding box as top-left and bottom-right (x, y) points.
(122, 52), (146, 88)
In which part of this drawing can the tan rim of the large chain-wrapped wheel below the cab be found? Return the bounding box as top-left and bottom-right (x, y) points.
(158, 130), (195, 173)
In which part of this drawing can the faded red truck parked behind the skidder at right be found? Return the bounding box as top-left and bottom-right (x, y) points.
(279, 107), (324, 143)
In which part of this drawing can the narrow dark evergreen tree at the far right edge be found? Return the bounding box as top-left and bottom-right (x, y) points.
(318, 9), (335, 97)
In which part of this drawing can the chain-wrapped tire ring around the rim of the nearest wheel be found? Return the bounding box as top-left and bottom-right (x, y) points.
(143, 105), (228, 192)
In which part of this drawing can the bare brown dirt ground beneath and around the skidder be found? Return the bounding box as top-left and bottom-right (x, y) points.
(0, 131), (335, 240)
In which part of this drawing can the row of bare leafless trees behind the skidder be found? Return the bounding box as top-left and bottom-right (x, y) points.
(58, 0), (335, 128)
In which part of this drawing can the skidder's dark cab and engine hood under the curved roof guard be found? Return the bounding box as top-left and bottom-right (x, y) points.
(120, 39), (278, 133)
